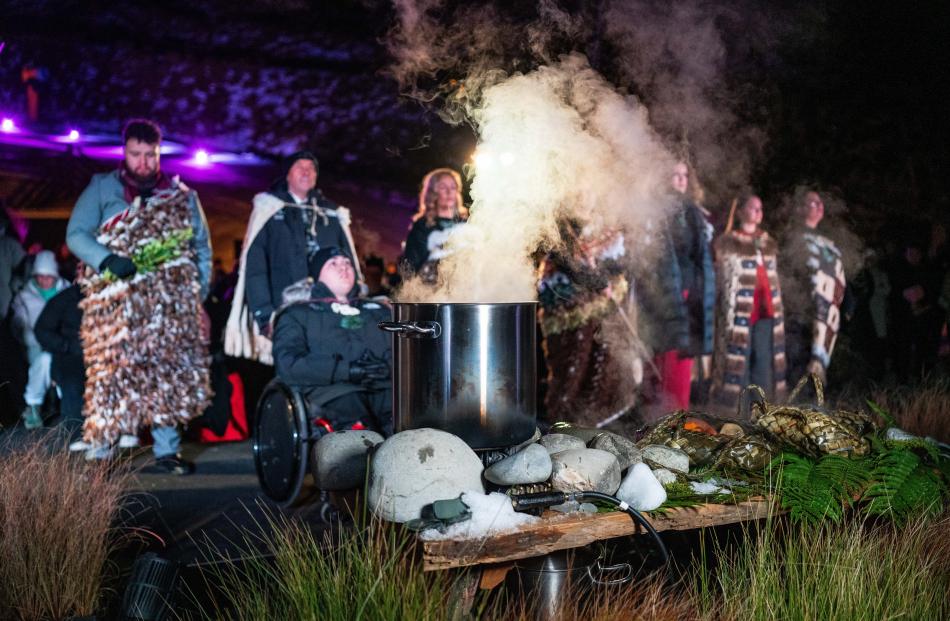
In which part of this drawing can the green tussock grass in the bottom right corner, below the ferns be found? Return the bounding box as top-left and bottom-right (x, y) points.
(694, 517), (950, 621)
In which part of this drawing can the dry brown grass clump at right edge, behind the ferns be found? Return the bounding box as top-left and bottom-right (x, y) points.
(869, 378), (950, 442)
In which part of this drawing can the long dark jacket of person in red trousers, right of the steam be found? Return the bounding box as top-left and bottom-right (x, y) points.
(637, 199), (716, 356)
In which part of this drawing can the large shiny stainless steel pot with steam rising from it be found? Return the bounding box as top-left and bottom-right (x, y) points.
(379, 302), (537, 449)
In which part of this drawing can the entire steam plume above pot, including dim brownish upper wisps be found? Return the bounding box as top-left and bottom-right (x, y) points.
(388, 0), (769, 302)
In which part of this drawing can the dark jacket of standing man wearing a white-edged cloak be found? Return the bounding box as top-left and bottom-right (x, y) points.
(245, 189), (356, 327)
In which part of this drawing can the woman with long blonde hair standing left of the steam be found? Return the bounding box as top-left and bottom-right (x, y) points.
(403, 168), (468, 282)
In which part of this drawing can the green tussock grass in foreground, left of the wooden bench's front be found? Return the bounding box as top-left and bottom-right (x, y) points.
(197, 519), (453, 621)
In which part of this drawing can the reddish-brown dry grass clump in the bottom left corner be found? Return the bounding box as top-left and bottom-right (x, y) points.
(0, 441), (128, 620)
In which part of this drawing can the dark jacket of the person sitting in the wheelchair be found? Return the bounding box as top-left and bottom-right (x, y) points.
(274, 282), (392, 401)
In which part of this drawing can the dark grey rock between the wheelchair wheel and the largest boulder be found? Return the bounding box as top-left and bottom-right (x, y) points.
(313, 430), (383, 490)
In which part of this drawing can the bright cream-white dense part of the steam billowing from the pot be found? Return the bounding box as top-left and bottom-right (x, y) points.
(400, 54), (672, 303)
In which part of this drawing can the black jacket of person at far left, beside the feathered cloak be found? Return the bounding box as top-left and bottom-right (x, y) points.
(33, 285), (85, 383)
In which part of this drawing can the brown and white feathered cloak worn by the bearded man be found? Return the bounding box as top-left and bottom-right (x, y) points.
(79, 189), (211, 444)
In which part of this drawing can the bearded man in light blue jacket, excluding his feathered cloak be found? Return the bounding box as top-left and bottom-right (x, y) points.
(66, 119), (211, 474)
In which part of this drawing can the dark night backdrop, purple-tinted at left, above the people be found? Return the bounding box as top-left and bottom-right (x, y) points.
(0, 0), (950, 252)
